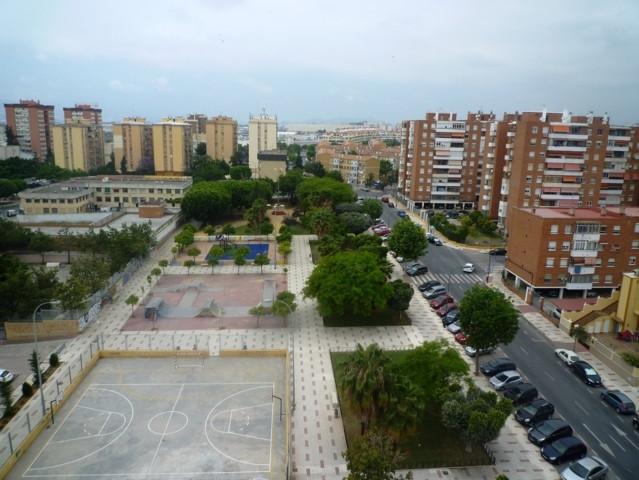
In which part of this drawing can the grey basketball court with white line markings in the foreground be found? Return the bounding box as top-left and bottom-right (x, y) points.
(8, 357), (286, 480)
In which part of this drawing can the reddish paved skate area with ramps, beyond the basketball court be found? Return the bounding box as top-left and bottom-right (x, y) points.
(122, 273), (287, 331)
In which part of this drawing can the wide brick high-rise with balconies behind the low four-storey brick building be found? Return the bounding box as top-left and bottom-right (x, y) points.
(498, 111), (639, 232)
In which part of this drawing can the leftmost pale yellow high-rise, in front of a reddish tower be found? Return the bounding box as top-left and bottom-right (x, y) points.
(53, 120), (104, 172)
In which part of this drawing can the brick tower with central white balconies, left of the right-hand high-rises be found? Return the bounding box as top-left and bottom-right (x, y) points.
(398, 112), (495, 209)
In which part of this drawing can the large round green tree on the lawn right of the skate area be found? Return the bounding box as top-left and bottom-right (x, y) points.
(304, 251), (391, 317)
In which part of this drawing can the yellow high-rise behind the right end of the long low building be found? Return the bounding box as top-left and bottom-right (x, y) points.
(153, 117), (192, 175)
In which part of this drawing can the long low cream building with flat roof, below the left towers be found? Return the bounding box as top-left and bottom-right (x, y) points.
(18, 175), (193, 215)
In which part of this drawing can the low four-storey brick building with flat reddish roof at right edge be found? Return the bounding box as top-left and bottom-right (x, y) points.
(505, 205), (639, 298)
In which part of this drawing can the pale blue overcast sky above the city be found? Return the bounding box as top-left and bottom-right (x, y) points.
(0, 0), (639, 123)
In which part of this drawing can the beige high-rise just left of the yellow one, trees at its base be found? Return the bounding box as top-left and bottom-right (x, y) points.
(113, 117), (153, 172)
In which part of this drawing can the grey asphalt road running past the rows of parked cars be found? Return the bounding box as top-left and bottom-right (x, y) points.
(361, 192), (639, 480)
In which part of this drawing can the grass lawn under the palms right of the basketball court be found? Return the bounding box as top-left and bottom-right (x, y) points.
(331, 351), (491, 469)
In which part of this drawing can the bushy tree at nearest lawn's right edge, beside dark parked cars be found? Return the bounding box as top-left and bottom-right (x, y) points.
(441, 384), (512, 449)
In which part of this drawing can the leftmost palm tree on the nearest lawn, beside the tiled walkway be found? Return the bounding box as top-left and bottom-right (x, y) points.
(340, 343), (390, 435)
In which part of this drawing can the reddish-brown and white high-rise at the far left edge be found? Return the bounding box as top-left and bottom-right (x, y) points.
(4, 100), (55, 162)
